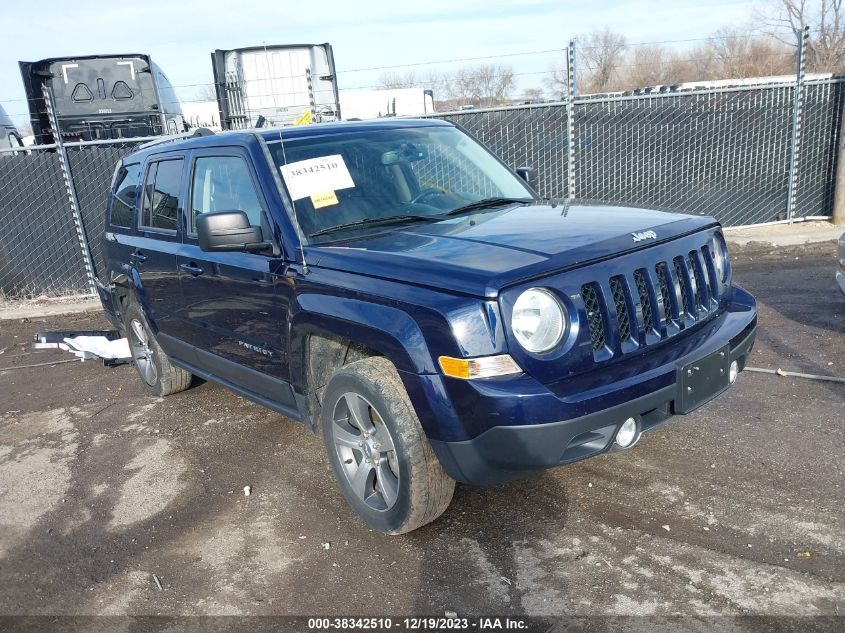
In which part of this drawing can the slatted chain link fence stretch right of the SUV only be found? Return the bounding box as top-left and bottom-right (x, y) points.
(434, 79), (845, 226)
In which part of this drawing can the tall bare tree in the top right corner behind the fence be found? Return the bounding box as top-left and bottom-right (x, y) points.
(762, 0), (845, 73)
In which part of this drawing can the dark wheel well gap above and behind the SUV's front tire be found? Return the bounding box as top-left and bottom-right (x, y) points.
(305, 334), (382, 430)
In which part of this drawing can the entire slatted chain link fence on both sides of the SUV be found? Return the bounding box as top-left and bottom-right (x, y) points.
(0, 78), (845, 299)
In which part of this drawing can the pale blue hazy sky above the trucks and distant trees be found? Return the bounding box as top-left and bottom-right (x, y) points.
(0, 0), (758, 122)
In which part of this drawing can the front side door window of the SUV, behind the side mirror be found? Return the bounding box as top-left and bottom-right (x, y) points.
(190, 156), (261, 233)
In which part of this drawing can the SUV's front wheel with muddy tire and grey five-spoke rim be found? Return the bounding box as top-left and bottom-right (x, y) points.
(321, 357), (455, 534)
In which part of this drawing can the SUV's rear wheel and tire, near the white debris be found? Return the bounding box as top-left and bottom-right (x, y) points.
(124, 304), (192, 396)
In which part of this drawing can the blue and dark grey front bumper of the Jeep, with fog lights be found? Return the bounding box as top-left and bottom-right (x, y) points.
(412, 286), (757, 485)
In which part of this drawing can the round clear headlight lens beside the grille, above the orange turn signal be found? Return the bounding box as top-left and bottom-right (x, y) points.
(511, 288), (566, 354)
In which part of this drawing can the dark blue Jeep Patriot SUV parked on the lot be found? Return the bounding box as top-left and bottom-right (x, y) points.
(100, 120), (756, 534)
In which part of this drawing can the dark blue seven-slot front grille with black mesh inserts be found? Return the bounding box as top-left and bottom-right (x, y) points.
(581, 247), (717, 360)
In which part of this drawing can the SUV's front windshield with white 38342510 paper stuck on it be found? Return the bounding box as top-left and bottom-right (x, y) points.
(268, 126), (533, 243)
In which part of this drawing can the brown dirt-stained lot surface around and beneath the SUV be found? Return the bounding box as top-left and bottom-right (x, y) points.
(0, 239), (845, 630)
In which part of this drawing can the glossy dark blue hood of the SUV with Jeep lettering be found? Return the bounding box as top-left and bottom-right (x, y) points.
(305, 204), (717, 297)
